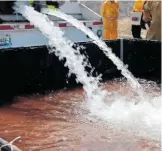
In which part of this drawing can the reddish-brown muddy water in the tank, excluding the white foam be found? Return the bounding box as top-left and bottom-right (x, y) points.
(0, 81), (160, 151)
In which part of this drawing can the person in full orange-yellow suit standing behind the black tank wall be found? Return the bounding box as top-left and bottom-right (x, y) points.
(101, 0), (119, 40)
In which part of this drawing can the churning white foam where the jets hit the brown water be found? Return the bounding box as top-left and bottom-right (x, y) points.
(90, 81), (162, 142)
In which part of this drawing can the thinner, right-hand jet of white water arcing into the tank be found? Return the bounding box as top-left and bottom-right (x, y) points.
(47, 9), (146, 103)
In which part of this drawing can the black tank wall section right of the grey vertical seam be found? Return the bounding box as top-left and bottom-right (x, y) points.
(124, 40), (161, 82)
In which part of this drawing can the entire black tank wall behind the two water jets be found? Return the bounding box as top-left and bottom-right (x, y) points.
(0, 39), (161, 103)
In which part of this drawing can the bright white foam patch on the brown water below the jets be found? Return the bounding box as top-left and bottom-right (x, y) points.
(91, 96), (162, 141)
